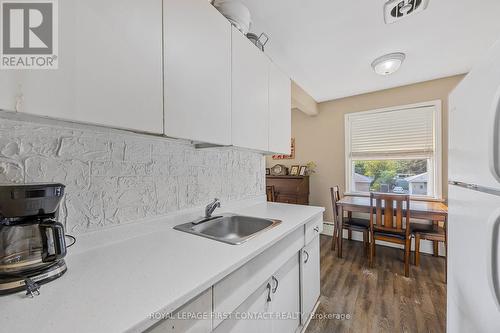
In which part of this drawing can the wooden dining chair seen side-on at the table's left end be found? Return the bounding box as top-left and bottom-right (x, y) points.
(330, 186), (370, 254)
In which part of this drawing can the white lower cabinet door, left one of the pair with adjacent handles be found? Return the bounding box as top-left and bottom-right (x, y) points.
(214, 280), (273, 333)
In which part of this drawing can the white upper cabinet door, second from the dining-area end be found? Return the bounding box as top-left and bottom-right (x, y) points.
(232, 28), (270, 151)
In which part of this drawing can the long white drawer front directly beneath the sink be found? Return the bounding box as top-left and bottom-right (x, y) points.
(213, 228), (304, 327)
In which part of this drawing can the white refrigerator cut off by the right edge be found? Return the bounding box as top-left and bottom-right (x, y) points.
(447, 38), (500, 333)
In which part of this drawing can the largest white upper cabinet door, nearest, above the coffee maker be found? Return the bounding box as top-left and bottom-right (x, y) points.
(0, 0), (163, 133)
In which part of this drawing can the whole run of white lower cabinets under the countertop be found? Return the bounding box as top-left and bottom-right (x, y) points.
(147, 217), (322, 333)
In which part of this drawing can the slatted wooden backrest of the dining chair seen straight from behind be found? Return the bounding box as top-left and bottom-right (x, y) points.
(370, 192), (410, 235)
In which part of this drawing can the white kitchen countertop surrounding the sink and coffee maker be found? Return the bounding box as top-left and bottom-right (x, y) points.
(0, 198), (324, 333)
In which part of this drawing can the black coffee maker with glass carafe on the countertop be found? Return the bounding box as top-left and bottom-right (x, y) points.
(0, 184), (66, 297)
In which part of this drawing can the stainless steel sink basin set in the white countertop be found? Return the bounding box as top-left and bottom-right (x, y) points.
(174, 214), (281, 245)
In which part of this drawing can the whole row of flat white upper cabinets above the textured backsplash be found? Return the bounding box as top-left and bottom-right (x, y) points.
(0, 0), (291, 148)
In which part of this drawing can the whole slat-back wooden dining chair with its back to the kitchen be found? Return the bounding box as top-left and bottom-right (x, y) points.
(369, 193), (411, 277)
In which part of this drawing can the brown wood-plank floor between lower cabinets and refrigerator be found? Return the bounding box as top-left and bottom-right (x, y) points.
(307, 235), (446, 333)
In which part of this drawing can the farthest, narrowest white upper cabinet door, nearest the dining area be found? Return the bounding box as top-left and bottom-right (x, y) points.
(269, 63), (292, 154)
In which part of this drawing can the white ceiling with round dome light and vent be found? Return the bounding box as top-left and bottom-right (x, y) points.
(242, 0), (500, 102)
